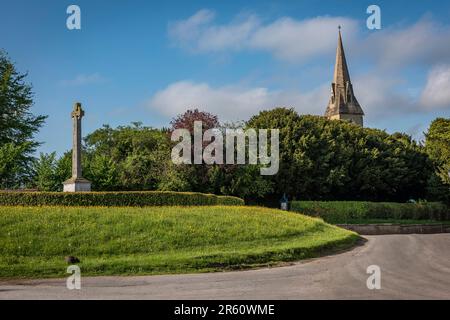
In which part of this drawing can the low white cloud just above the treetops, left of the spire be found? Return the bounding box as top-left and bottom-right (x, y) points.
(148, 81), (329, 121)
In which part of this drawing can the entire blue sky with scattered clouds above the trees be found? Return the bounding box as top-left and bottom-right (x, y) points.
(0, 0), (450, 154)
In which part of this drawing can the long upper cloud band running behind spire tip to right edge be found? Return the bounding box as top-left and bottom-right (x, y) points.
(169, 9), (450, 68)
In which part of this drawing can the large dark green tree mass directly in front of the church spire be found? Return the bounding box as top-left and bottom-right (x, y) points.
(248, 108), (433, 201)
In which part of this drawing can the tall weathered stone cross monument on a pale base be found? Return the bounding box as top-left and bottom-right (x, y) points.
(63, 102), (91, 192)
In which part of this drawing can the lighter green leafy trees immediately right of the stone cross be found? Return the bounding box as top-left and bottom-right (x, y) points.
(83, 123), (170, 191)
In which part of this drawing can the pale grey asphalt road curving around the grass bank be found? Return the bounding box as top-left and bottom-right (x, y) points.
(0, 234), (450, 299)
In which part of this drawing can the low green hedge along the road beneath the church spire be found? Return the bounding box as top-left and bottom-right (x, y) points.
(291, 201), (450, 223)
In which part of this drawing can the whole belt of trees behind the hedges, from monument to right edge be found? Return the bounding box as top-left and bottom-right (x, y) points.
(28, 108), (448, 202)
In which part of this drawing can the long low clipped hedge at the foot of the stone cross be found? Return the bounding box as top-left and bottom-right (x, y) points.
(0, 191), (244, 207)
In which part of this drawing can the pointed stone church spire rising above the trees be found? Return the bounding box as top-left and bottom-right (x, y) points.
(325, 27), (364, 126)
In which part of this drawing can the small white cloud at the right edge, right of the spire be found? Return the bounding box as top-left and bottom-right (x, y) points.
(420, 65), (450, 109)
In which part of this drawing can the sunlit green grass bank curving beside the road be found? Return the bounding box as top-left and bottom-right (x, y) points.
(0, 206), (359, 278)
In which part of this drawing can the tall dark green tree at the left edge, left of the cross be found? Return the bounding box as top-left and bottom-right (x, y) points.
(0, 51), (46, 188)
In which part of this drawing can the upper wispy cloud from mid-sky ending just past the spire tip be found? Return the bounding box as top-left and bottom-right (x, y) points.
(169, 9), (357, 62)
